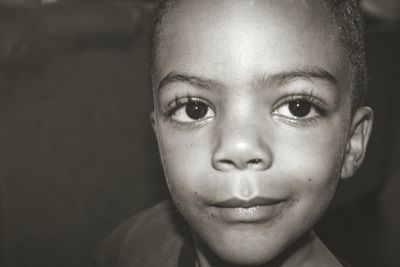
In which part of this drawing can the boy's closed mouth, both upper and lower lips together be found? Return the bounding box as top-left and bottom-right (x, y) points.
(212, 197), (286, 224)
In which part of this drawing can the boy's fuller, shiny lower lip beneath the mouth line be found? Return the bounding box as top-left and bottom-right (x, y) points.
(212, 202), (284, 223)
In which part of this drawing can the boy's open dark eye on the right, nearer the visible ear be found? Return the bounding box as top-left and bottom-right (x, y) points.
(273, 98), (323, 120)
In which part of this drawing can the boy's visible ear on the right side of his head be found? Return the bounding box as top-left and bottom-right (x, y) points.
(340, 107), (374, 179)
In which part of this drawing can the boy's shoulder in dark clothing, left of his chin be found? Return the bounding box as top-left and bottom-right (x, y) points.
(95, 202), (190, 267)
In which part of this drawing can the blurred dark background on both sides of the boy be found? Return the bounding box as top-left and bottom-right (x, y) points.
(0, 0), (400, 267)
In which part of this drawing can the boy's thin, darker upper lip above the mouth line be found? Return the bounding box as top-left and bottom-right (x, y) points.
(212, 197), (284, 208)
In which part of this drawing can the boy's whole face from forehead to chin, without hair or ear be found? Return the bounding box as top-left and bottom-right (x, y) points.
(153, 0), (368, 264)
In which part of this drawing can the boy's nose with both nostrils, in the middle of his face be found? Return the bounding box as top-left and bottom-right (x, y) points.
(212, 119), (273, 171)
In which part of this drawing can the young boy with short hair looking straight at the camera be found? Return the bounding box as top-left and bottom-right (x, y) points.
(97, 0), (372, 267)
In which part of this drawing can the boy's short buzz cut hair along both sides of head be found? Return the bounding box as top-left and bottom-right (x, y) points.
(150, 0), (367, 112)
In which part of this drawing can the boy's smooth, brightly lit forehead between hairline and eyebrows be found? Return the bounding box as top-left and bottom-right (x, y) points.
(155, 0), (349, 93)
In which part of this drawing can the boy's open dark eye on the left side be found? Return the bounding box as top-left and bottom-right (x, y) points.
(171, 99), (215, 123)
